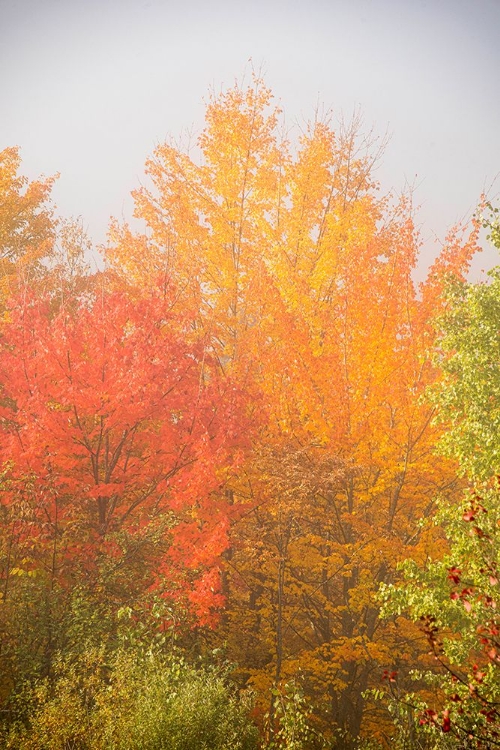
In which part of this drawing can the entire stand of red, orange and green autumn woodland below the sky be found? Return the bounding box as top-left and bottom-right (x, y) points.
(0, 77), (500, 750)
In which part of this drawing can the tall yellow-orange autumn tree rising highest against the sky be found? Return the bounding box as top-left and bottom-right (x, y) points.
(107, 79), (475, 746)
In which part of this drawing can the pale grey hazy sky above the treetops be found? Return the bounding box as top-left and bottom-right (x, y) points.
(0, 0), (500, 278)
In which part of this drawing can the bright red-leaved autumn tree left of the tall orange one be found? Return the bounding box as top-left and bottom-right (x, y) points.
(0, 279), (249, 712)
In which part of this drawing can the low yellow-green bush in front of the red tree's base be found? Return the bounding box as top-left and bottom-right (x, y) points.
(5, 636), (257, 750)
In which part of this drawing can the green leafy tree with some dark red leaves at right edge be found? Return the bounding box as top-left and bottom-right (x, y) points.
(378, 204), (500, 748)
